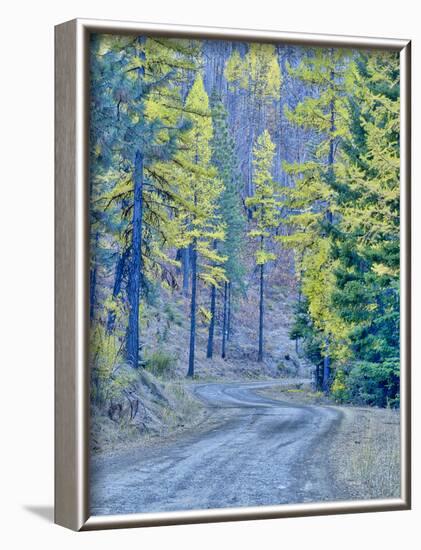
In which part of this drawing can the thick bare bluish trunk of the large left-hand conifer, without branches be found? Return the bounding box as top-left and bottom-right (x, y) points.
(126, 150), (143, 368)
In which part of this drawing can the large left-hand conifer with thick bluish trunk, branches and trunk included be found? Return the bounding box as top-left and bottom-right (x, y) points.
(91, 35), (197, 367)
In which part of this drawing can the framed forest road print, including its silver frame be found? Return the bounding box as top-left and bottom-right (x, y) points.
(55, 19), (410, 530)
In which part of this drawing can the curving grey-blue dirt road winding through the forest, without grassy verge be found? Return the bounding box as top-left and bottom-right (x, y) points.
(90, 382), (347, 515)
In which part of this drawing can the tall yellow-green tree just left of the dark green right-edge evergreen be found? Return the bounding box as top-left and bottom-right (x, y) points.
(282, 48), (350, 391)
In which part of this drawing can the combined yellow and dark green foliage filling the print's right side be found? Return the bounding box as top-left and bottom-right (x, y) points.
(282, 50), (400, 406)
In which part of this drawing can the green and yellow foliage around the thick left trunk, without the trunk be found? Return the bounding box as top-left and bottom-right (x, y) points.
(90, 34), (204, 338)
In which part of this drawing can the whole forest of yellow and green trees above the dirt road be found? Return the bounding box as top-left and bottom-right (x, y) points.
(90, 35), (400, 444)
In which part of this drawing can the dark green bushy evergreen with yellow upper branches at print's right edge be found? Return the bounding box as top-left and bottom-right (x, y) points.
(332, 53), (400, 405)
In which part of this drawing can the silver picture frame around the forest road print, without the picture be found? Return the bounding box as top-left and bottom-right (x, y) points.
(55, 19), (411, 531)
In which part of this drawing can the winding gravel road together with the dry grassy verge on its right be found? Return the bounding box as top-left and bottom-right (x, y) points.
(91, 380), (399, 514)
